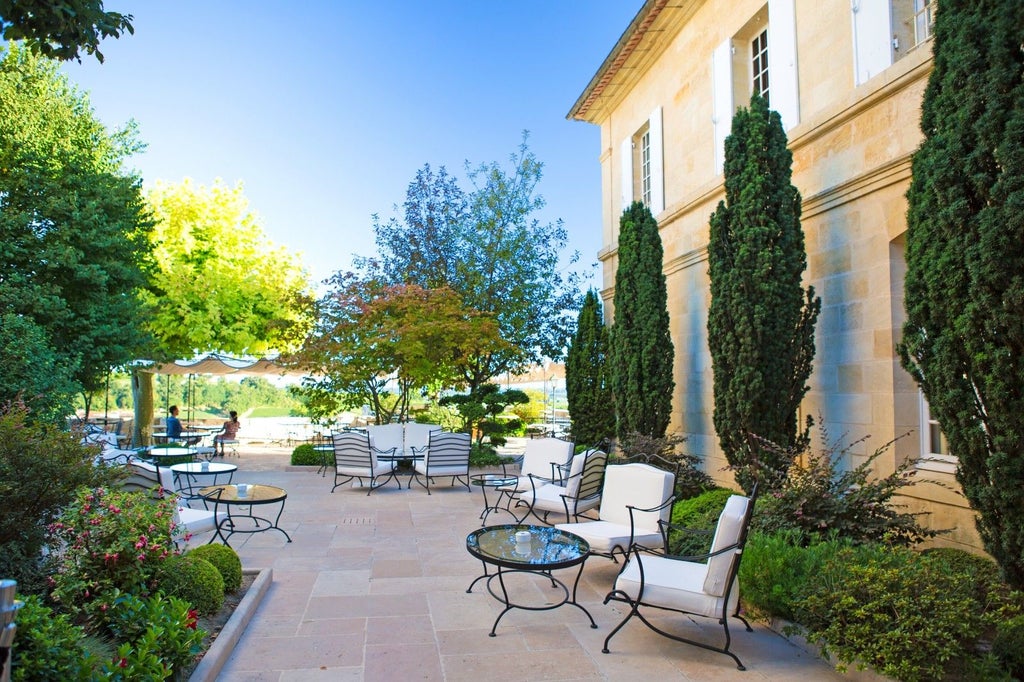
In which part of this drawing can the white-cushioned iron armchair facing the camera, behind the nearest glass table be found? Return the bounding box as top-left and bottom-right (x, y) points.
(555, 464), (676, 561)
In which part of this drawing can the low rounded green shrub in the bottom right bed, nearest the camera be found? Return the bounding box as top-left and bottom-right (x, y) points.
(795, 545), (1001, 681)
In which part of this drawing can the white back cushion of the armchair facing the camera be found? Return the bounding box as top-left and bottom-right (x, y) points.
(600, 464), (676, 534)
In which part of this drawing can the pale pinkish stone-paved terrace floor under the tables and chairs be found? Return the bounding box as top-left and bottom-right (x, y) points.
(198, 444), (850, 682)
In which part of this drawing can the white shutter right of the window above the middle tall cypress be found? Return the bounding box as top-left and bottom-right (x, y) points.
(768, 0), (798, 130)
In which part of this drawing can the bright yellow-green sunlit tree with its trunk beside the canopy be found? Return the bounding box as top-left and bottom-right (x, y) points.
(132, 179), (313, 442)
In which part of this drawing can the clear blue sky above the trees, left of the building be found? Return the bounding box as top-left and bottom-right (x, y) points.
(66, 0), (642, 285)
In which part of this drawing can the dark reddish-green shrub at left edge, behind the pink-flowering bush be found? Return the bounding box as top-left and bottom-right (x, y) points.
(0, 403), (117, 594)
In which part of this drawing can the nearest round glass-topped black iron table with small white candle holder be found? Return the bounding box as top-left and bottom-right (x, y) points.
(466, 523), (597, 637)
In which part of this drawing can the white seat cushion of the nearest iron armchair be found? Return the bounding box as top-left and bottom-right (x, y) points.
(615, 555), (739, 619)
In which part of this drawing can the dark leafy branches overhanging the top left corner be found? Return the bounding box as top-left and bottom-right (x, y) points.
(0, 0), (135, 62)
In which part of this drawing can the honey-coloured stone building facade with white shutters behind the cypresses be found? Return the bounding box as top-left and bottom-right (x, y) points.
(568, 0), (980, 549)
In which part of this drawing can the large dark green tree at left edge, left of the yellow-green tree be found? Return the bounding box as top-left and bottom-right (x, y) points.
(0, 46), (152, 416)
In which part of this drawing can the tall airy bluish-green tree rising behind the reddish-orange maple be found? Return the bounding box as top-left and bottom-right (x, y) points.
(359, 133), (578, 391)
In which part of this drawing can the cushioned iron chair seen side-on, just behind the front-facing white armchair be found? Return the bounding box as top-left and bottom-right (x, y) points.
(516, 450), (608, 523)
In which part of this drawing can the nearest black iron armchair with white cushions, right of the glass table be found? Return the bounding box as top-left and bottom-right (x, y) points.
(601, 488), (757, 670)
